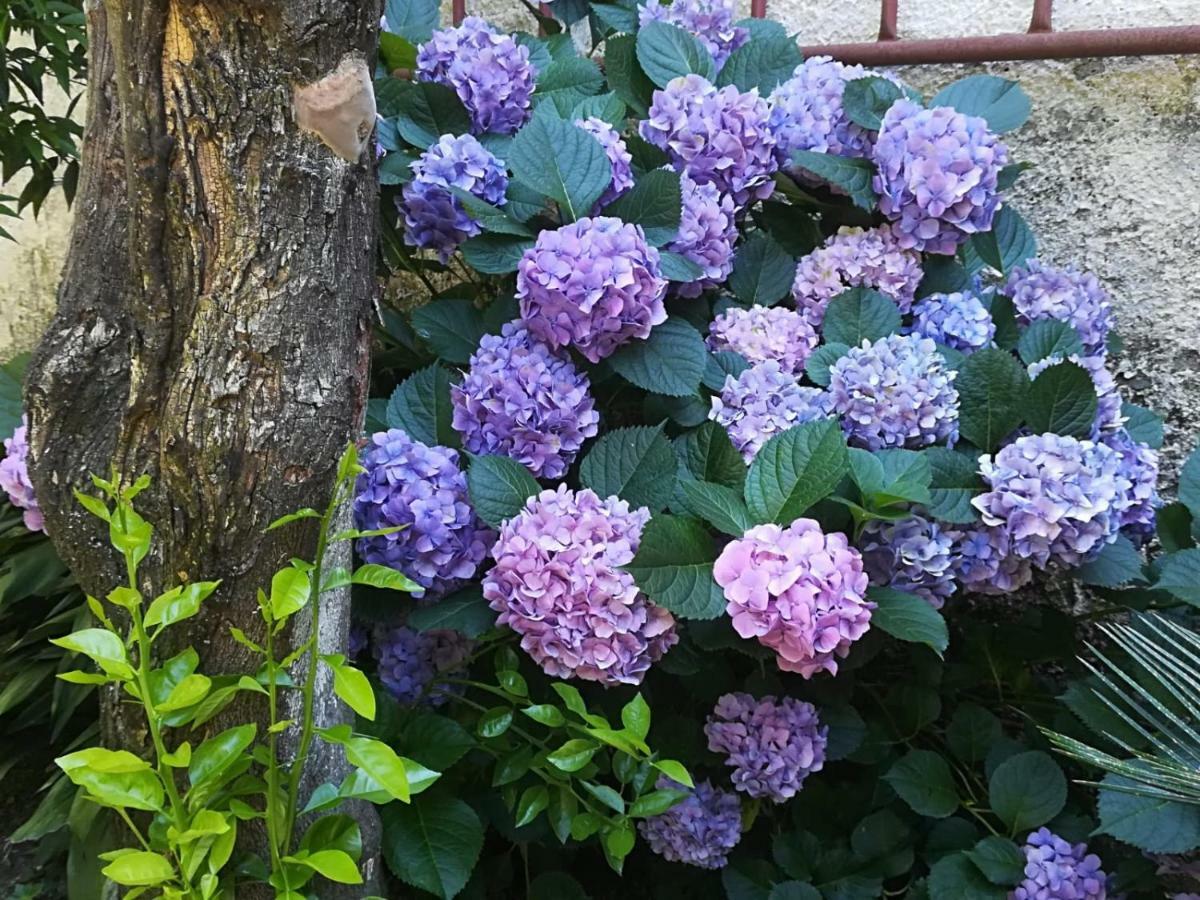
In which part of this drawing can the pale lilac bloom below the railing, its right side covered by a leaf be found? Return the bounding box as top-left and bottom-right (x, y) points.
(769, 56), (888, 162)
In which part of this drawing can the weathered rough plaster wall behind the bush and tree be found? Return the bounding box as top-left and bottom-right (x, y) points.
(0, 0), (1200, 464)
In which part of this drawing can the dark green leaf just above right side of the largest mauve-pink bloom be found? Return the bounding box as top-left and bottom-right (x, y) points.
(580, 425), (677, 511)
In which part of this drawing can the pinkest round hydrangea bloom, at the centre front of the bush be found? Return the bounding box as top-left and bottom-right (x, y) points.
(713, 518), (875, 678)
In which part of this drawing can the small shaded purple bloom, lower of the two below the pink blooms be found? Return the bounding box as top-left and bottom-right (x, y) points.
(637, 778), (742, 869)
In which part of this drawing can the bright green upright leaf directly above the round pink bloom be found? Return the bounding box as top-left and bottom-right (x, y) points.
(745, 419), (850, 526)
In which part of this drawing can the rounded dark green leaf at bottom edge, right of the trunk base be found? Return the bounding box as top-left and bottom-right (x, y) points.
(380, 793), (484, 900)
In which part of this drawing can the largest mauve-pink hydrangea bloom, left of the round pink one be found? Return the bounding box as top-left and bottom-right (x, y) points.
(484, 485), (679, 684)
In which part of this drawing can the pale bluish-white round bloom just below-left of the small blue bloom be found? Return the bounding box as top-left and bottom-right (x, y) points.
(829, 335), (959, 450)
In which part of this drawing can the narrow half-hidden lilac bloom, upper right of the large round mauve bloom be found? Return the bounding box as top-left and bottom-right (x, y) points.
(667, 173), (738, 296)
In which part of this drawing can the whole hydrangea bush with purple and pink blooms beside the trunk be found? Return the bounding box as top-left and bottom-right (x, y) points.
(355, 0), (1200, 900)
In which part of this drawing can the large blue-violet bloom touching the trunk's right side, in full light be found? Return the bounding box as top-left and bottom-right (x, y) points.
(354, 428), (496, 599)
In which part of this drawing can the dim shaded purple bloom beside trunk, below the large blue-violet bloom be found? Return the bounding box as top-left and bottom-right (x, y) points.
(373, 625), (474, 707)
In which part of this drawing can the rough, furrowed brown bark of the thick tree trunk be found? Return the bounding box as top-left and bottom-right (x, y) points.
(26, 0), (379, 896)
